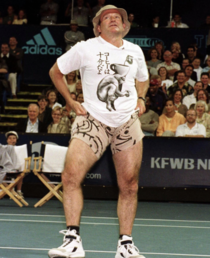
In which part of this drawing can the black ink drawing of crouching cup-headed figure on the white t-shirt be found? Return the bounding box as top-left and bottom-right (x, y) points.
(97, 56), (133, 111)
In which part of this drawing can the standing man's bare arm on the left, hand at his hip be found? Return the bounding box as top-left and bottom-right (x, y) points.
(49, 62), (87, 116)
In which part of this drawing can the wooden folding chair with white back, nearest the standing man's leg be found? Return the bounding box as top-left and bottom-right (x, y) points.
(33, 143), (68, 208)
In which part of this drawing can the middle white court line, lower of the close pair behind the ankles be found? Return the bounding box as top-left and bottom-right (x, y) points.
(0, 219), (210, 229)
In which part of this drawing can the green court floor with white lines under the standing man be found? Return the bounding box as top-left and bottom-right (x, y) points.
(0, 198), (210, 258)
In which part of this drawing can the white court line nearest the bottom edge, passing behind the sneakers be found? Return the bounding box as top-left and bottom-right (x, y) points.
(0, 246), (210, 257)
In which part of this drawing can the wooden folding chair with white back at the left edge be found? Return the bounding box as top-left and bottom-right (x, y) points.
(0, 143), (32, 207)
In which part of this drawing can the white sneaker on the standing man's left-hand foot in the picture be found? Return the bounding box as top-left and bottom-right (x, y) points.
(48, 229), (85, 258)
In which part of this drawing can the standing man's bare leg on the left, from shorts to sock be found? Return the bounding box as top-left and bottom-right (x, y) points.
(62, 139), (97, 226)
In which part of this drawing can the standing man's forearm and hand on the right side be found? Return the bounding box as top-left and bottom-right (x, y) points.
(135, 80), (149, 116)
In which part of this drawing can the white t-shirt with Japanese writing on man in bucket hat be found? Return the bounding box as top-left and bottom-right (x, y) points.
(57, 36), (148, 127)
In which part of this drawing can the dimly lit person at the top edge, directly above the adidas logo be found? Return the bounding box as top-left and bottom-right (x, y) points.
(39, 0), (59, 25)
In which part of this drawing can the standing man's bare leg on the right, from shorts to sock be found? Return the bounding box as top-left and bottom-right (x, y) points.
(113, 141), (142, 235)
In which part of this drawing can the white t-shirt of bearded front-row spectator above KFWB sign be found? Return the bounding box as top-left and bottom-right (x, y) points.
(176, 123), (206, 137)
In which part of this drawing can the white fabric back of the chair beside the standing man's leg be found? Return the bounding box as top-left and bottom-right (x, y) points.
(42, 144), (68, 173)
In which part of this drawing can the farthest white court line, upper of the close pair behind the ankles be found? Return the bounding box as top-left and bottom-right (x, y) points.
(0, 213), (210, 223)
